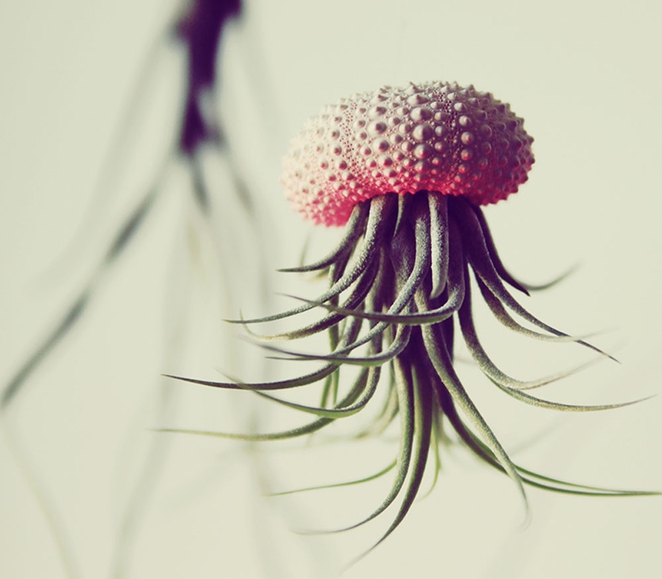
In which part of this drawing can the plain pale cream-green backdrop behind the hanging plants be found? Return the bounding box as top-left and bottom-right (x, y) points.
(0, 0), (662, 579)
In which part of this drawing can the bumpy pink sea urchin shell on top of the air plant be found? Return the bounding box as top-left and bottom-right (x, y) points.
(282, 82), (534, 225)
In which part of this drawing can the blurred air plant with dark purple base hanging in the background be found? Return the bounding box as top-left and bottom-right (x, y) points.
(0, 0), (256, 577)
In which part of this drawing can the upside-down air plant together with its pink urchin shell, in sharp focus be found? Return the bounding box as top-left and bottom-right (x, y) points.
(169, 82), (656, 552)
